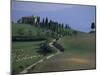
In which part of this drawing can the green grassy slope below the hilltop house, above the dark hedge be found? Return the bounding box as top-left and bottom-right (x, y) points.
(12, 23), (60, 41)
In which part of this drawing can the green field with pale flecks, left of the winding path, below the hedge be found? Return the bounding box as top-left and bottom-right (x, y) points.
(12, 41), (43, 73)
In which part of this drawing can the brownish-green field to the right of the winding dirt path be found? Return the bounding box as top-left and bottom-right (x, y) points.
(28, 33), (96, 72)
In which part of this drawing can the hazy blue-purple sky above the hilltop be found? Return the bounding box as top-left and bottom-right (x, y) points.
(11, 1), (96, 32)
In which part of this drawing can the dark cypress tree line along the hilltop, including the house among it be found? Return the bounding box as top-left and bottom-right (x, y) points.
(17, 16), (72, 37)
